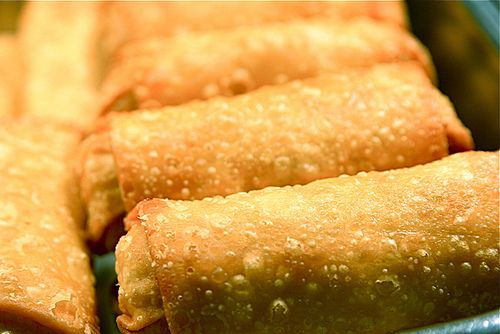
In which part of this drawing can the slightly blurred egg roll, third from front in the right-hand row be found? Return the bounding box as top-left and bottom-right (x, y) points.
(99, 18), (434, 114)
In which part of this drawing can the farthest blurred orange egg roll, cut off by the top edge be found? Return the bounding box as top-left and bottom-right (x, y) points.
(101, 0), (406, 56)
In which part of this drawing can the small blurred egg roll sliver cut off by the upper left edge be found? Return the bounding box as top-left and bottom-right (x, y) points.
(0, 34), (22, 117)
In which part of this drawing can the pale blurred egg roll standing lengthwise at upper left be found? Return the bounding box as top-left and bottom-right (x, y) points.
(20, 1), (101, 129)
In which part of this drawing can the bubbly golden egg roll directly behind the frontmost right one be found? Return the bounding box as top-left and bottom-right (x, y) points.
(79, 63), (472, 248)
